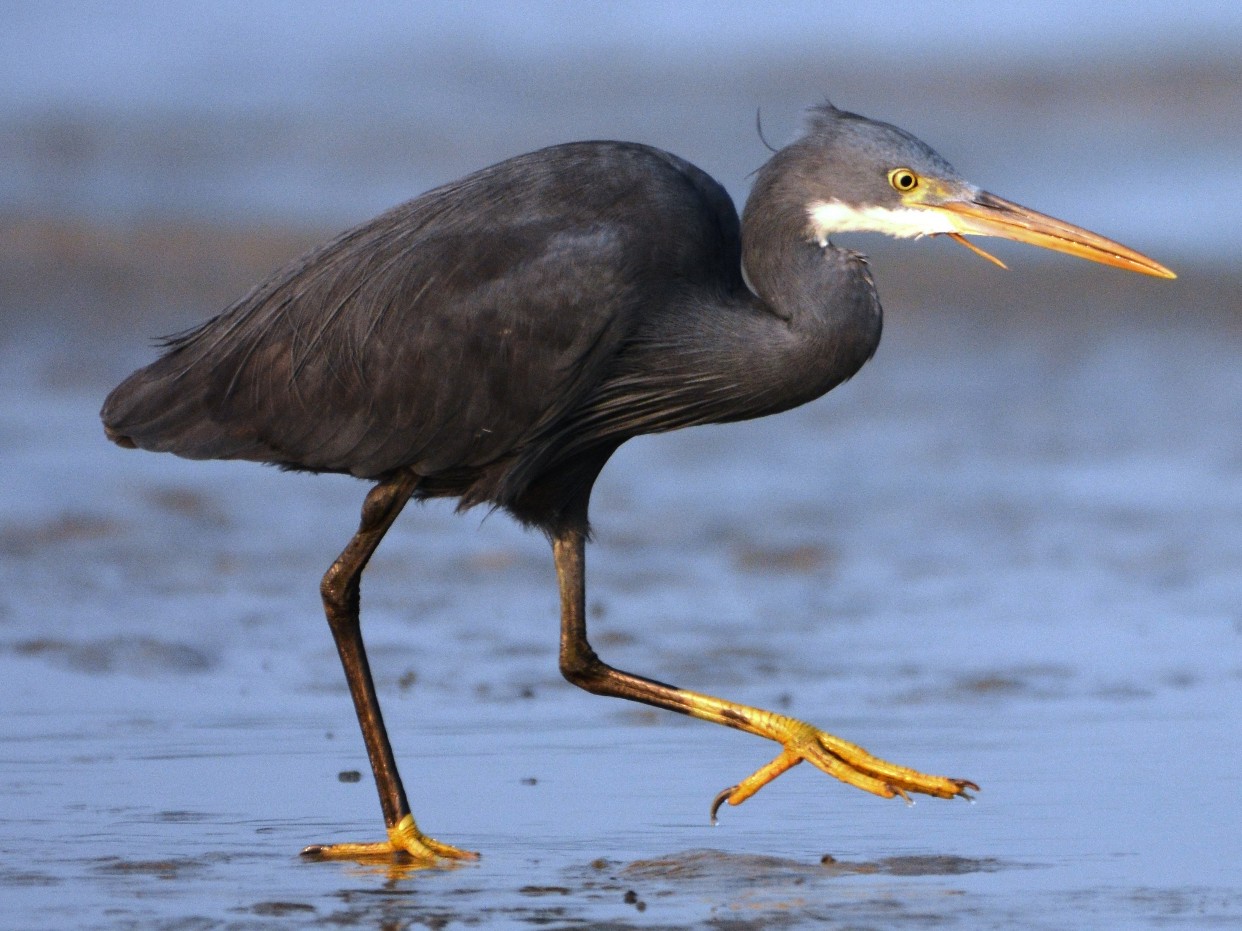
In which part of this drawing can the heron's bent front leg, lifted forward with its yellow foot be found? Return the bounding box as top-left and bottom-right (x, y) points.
(553, 530), (979, 821)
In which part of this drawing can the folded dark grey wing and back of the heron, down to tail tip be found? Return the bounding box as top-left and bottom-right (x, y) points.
(103, 143), (740, 511)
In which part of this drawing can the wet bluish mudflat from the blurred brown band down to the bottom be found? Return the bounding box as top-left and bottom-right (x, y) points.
(0, 216), (1242, 929)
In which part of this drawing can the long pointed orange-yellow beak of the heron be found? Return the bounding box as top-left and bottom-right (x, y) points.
(928, 191), (1177, 278)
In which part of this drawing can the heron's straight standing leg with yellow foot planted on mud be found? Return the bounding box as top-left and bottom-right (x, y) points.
(302, 473), (478, 865)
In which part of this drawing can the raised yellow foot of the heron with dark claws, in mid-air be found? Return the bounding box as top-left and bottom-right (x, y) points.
(712, 709), (979, 824)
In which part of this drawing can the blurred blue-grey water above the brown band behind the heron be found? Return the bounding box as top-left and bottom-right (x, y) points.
(0, 0), (1242, 248)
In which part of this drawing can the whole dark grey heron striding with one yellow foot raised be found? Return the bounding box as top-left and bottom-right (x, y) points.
(102, 103), (1175, 865)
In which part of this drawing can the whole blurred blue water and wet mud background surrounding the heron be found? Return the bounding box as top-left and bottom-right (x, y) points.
(0, 0), (1242, 927)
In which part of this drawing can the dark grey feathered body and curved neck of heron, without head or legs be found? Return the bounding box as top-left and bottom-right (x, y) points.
(102, 135), (881, 533)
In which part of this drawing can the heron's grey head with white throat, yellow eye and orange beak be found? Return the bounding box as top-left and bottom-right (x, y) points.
(791, 104), (1176, 278)
